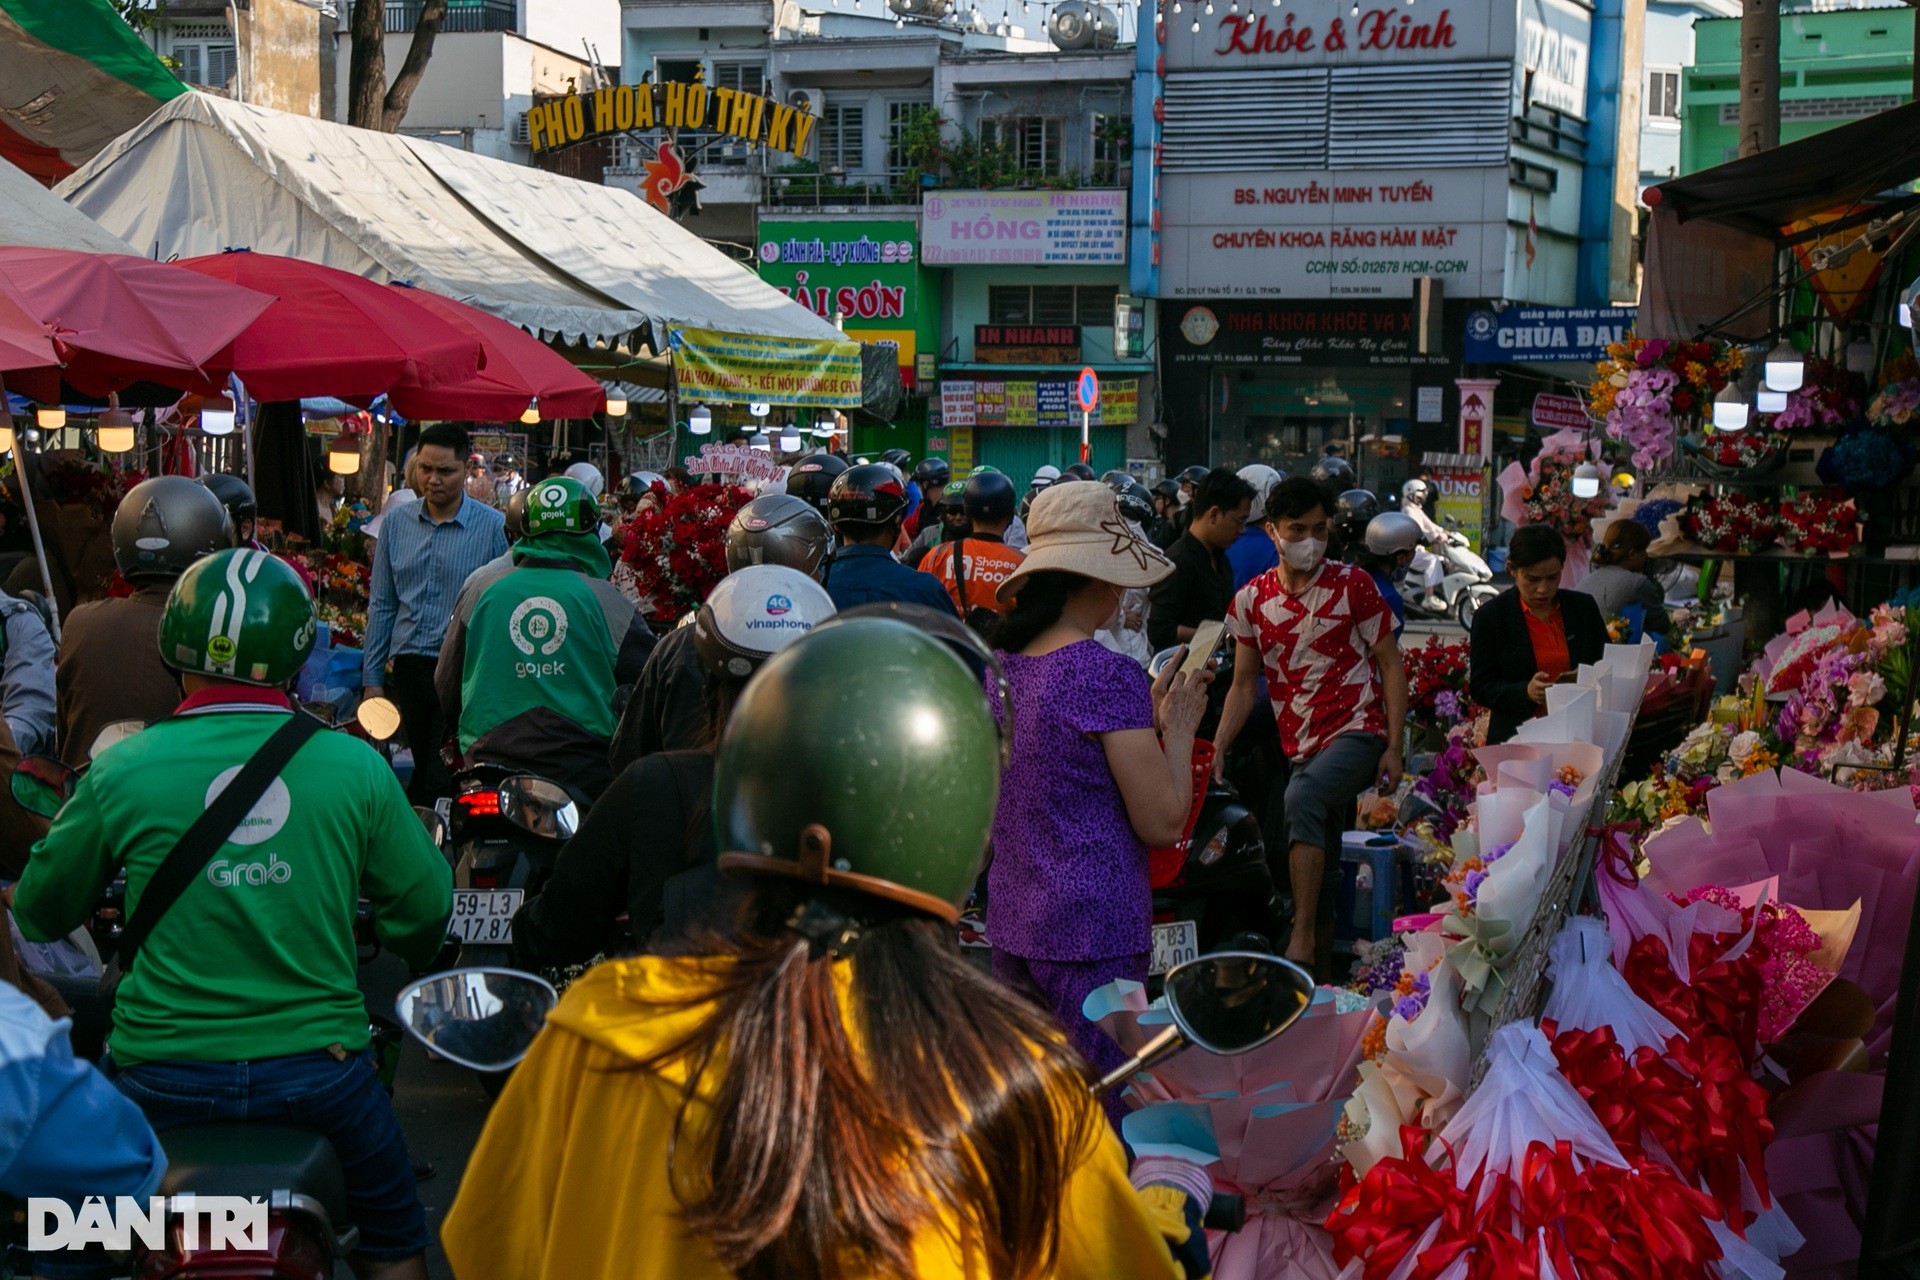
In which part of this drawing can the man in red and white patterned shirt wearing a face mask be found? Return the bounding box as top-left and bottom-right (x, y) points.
(1213, 476), (1407, 967)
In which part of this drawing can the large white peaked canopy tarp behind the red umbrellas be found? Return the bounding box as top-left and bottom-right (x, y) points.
(56, 94), (845, 347)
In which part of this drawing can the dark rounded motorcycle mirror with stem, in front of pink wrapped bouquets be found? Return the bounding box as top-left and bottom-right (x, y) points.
(1094, 952), (1313, 1096)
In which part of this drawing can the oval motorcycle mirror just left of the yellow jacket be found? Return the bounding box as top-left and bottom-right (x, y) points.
(394, 969), (561, 1071)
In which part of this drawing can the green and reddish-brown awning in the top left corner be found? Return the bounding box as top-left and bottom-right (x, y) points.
(0, 0), (186, 182)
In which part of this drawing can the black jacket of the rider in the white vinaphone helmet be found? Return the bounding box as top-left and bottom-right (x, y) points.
(513, 750), (724, 969)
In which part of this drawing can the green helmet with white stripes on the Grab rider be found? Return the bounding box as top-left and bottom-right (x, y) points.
(159, 549), (313, 689)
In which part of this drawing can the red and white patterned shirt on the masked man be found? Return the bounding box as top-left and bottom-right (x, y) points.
(1227, 560), (1394, 762)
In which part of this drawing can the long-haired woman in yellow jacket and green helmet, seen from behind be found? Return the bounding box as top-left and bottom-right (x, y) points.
(442, 618), (1210, 1280)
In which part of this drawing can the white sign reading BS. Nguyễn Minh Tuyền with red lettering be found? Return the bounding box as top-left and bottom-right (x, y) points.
(1160, 167), (1507, 297)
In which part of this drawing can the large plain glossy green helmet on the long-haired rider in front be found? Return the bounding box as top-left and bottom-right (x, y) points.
(714, 618), (1000, 921)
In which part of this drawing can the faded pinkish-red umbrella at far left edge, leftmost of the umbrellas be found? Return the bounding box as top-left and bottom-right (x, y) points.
(0, 246), (273, 403)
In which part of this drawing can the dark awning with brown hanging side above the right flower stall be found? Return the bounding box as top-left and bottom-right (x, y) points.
(1634, 102), (1920, 342)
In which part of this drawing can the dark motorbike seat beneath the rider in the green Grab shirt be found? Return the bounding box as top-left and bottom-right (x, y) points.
(159, 1121), (349, 1234)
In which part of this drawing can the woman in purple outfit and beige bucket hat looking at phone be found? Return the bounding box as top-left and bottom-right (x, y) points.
(987, 484), (1206, 1115)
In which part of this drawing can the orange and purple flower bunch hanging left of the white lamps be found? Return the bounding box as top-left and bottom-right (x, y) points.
(1588, 338), (1741, 466)
